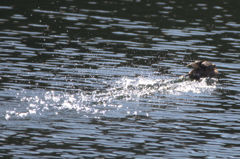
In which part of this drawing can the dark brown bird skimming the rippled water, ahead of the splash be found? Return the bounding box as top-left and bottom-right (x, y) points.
(187, 61), (219, 80)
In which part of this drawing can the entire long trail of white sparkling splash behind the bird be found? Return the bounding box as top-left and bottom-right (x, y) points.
(5, 77), (217, 120)
